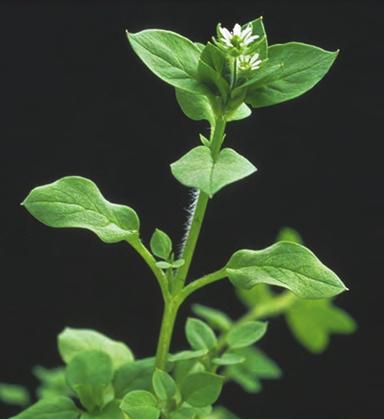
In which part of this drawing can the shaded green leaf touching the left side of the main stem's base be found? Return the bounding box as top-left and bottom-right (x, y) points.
(113, 358), (155, 398)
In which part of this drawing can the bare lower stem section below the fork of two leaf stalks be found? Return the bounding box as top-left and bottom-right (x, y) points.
(155, 300), (180, 370)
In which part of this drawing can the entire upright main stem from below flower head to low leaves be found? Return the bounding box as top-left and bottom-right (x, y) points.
(155, 116), (226, 370)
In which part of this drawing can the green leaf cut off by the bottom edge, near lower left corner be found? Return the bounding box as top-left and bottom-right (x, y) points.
(10, 397), (80, 419)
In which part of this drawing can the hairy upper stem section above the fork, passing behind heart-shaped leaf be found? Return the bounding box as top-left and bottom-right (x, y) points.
(175, 117), (226, 291)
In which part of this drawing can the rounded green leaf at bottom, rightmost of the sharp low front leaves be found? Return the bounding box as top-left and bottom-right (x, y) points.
(181, 372), (223, 407)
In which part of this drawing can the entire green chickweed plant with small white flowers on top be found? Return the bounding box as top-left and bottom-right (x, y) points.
(0, 18), (355, 419)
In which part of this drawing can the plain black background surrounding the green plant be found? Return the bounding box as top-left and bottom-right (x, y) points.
(0, 1), (384, 419)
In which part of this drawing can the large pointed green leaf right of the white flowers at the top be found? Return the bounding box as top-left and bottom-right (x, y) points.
(242, 42), (338, 108)
